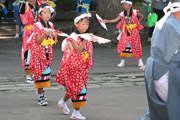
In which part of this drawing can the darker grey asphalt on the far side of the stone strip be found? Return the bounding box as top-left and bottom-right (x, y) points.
(0, 38), (150, 76)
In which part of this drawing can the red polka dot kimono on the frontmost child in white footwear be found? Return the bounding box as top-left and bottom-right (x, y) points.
(56, 33), (93, 99)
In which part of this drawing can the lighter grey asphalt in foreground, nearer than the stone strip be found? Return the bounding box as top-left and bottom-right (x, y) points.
(0, 86), (147, 120)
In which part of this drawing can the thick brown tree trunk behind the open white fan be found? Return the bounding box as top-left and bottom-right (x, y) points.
(96, 0), (122, 43)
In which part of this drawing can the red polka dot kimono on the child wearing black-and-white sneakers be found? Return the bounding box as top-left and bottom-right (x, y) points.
(28, 22), (54, 82)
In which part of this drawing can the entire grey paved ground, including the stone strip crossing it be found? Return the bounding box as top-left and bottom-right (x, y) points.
(0, 20), (149, 120)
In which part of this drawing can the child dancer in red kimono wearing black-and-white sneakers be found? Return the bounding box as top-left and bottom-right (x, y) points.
(28, 4), (54, 106)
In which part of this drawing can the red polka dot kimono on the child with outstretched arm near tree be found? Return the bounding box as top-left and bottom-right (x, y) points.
(116, 10), (143, 60)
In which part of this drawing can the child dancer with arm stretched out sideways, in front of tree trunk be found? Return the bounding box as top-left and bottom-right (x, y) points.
(104, 0), (144, 67)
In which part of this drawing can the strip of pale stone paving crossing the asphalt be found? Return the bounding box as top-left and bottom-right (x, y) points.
(0, 73), (145, 92)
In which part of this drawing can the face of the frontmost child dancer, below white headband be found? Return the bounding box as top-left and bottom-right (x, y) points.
(75, 18), (89, 33)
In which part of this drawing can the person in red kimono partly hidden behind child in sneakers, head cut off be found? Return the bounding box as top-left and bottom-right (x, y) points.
(19, 0), (55, 83)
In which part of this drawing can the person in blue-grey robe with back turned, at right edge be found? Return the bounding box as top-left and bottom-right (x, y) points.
(144, 0), (180, 120)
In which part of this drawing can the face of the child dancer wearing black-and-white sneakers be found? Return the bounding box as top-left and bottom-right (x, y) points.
(40, 8), (51, 21)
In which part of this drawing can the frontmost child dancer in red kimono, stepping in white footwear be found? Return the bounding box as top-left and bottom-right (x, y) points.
(56, 13), (93, 120)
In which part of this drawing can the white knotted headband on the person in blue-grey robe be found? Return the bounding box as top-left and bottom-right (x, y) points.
(154, 2), (180, 31)
